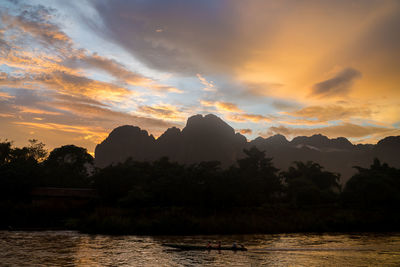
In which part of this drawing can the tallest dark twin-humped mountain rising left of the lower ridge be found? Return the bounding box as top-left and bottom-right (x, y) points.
(95, 114), (247, 167)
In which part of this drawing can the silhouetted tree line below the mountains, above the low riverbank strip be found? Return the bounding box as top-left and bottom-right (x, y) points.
(0, 140), (400, 209)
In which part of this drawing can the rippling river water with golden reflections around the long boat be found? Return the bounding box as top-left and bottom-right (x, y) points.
(0, 231), (400, 266)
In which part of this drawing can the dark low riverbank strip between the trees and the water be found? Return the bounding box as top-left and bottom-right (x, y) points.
(0, 206), (400, 235)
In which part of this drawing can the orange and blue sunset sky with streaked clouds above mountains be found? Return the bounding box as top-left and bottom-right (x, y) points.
(0, 0), (400, 152)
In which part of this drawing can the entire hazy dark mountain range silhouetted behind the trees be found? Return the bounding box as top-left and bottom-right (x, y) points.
(95, 114), (400, 182)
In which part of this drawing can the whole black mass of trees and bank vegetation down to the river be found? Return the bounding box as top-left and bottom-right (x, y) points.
(0, 140), (400, 233)
